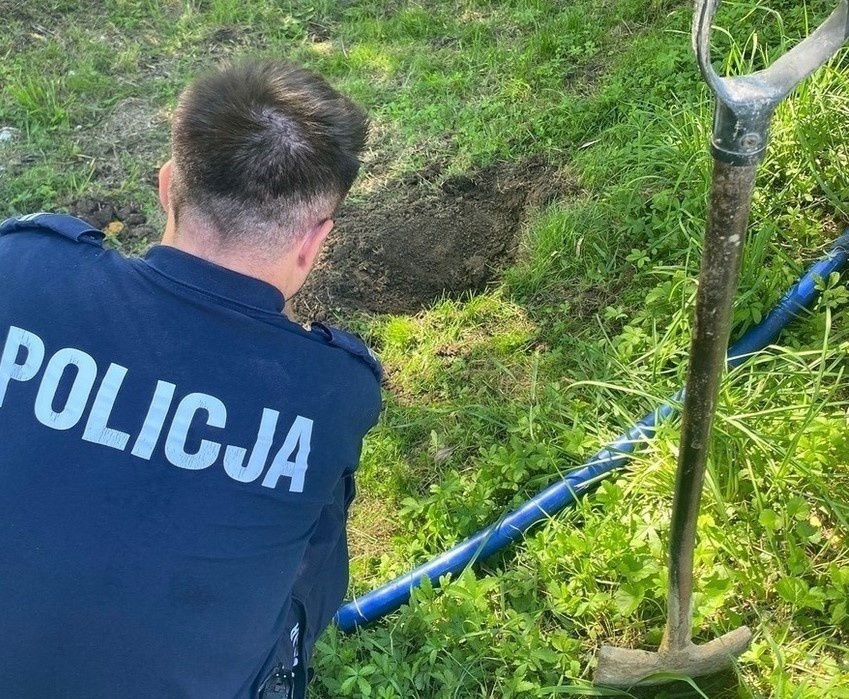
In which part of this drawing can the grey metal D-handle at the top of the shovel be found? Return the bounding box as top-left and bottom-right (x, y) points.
(693, 0), (849, 165)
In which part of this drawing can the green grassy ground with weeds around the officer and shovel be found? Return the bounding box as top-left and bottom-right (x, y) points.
(0, 0), (849, 699)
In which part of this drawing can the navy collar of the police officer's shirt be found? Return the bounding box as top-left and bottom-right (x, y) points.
(142, 245), (286, 313)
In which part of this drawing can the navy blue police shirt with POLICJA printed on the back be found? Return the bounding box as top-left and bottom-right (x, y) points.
(0, 214), (380, 699)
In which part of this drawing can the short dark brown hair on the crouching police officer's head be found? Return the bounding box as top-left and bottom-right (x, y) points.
(169, 59), (368, 253)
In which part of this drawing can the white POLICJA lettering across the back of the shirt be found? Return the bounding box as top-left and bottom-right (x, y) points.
(0, 326), (313, 493)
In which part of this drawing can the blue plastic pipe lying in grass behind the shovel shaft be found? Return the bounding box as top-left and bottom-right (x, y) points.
(336, 229), (849, 633)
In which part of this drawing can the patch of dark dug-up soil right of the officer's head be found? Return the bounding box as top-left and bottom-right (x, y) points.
(293, 159), (569, 318)
